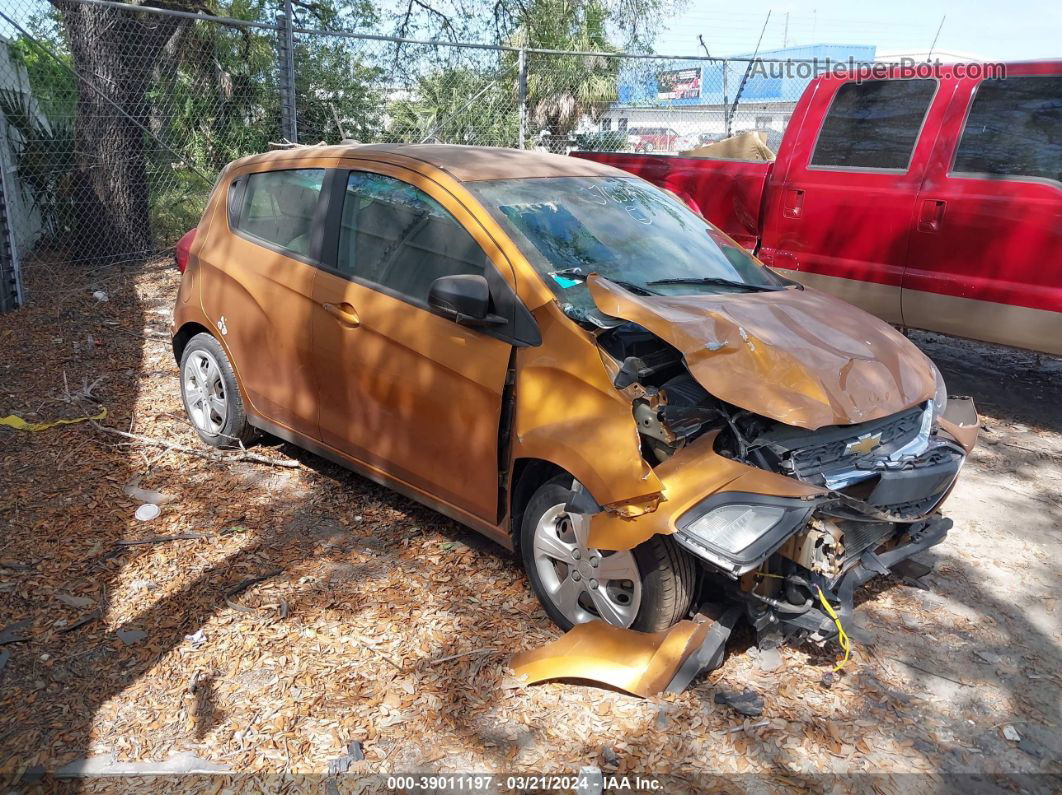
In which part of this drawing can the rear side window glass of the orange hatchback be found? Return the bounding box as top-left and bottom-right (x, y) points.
(236, 169), (325, 257)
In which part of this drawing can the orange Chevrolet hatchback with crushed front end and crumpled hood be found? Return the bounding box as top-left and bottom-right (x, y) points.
(173, 144), (977, 658)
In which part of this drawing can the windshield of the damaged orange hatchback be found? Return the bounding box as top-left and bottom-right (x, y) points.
(466, 176), (789, 318)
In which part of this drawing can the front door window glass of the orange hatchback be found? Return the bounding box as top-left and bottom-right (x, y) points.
(337, 171), (486, 304)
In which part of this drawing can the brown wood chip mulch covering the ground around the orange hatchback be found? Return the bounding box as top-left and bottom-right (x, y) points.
(0, 258), (1060, 789)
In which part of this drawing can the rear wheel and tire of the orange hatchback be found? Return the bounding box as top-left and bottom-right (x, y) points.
(181, 333), (258, 448)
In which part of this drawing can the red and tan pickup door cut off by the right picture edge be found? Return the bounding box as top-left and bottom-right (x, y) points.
(903, 65), (1062, 353)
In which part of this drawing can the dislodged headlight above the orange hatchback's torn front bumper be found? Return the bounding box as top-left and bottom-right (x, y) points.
(675, 492), (813, 576)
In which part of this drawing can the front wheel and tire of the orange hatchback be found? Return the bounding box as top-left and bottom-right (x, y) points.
(519, 476), (697, 633)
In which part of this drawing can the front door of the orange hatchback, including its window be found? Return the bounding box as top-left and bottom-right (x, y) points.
(312, 165), (512, 521)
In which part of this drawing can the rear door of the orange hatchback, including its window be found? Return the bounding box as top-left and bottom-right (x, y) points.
(200, 165), (327, 438)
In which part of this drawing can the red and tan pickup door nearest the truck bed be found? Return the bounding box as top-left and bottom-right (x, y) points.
(760, 77), (941, 324)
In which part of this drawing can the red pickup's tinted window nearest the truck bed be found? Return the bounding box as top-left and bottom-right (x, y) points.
(811, 79), (937, 171)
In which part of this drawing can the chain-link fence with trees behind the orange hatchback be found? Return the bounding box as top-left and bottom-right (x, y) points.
(0, 0), (870, 309)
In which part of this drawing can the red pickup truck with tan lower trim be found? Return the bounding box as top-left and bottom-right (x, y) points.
(573, 61), (1062, 355)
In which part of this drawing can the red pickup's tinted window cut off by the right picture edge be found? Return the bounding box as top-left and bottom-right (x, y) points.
(953, 75), (1062, 182)
